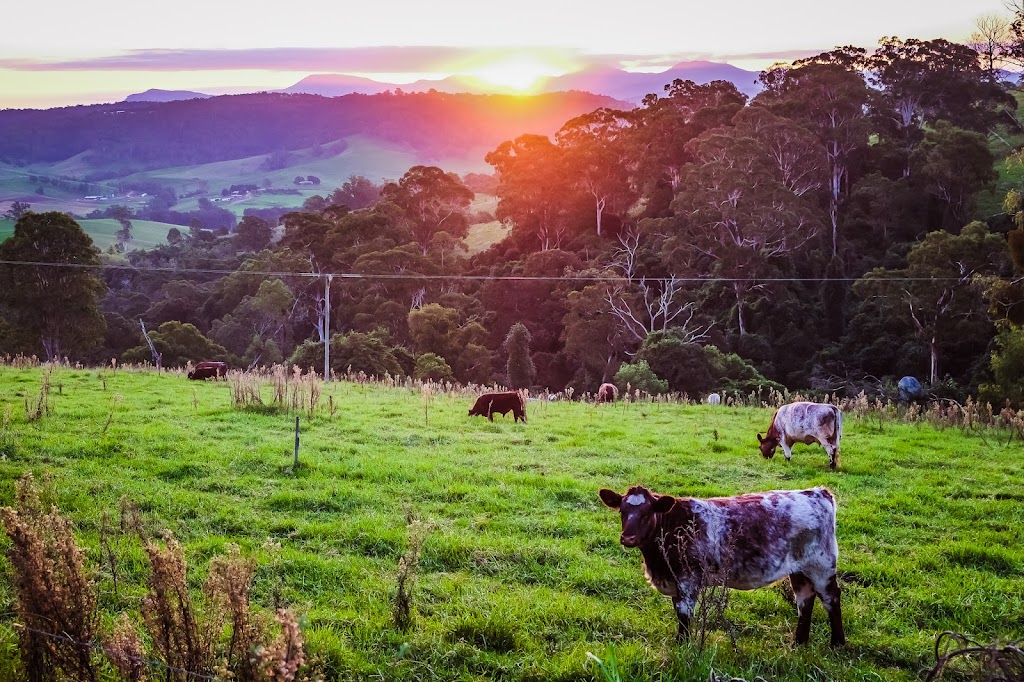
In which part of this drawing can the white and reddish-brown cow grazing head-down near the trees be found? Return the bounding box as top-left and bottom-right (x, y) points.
(758, 402), (843, 469)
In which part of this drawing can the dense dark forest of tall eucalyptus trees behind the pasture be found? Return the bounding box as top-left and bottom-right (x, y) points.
(0, 38), (1024, 404)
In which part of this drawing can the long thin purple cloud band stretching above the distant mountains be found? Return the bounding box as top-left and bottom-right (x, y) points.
(0, 46), (820, 74)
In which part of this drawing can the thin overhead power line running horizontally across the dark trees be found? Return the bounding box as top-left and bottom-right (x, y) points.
(0, 260), (987, 284)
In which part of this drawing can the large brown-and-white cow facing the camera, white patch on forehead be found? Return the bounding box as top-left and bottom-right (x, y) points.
(599, 486), (846, 646)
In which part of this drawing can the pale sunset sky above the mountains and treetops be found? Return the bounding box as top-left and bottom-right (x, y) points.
(0, 0), (1008, 109)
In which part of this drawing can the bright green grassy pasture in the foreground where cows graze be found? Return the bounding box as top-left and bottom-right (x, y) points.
(0, 368), (1024, 682)
